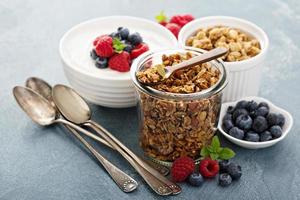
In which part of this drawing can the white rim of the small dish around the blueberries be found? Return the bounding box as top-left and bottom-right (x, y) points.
(218, 96), (294, 147)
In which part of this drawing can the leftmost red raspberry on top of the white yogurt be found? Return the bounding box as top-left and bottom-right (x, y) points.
(95, 36), (114, 58)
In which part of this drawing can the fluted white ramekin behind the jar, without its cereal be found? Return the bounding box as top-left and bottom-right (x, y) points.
(178, 16), (269, 102)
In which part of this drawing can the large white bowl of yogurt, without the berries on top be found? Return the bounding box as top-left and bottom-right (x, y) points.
(59, 16), (177, 107)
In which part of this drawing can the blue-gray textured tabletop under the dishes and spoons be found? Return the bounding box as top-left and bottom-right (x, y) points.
(0, 0), (300, 200)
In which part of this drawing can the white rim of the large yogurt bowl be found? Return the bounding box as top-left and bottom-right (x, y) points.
(58, 15), (178, 81)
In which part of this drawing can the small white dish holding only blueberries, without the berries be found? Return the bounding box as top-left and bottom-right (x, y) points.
(218, 96), (293, 149)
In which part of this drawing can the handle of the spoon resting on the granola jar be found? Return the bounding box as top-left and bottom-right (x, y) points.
(166, 47), (228, 74)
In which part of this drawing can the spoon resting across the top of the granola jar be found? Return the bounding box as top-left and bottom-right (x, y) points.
(137, 47), (228, 86)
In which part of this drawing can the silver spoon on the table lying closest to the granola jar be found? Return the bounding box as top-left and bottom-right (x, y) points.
(52, 85), (181, 194)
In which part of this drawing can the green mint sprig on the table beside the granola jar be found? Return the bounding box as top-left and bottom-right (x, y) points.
(200, 136), (235, 160)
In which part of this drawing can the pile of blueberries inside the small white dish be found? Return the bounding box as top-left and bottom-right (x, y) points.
(222, 100), (285, 142)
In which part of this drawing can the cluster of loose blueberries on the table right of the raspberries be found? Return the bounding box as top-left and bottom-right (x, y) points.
(219, 160), (242, 187)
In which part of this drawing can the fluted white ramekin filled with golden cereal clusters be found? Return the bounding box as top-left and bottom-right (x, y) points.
(178, 16), (269, 101)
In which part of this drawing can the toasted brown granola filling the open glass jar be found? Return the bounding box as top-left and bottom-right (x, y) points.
(139, 53), (221, 161)
